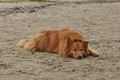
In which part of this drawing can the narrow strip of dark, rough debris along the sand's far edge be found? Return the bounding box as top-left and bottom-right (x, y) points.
(0, 0), (120, 15)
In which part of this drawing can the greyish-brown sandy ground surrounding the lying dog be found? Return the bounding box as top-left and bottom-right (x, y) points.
(0, 2), (120, 80)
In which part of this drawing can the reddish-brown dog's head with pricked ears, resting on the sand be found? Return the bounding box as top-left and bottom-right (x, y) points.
(68, 37), (89, 59)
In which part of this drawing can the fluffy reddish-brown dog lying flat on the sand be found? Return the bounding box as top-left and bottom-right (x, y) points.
(17, 28), (99, 59)
